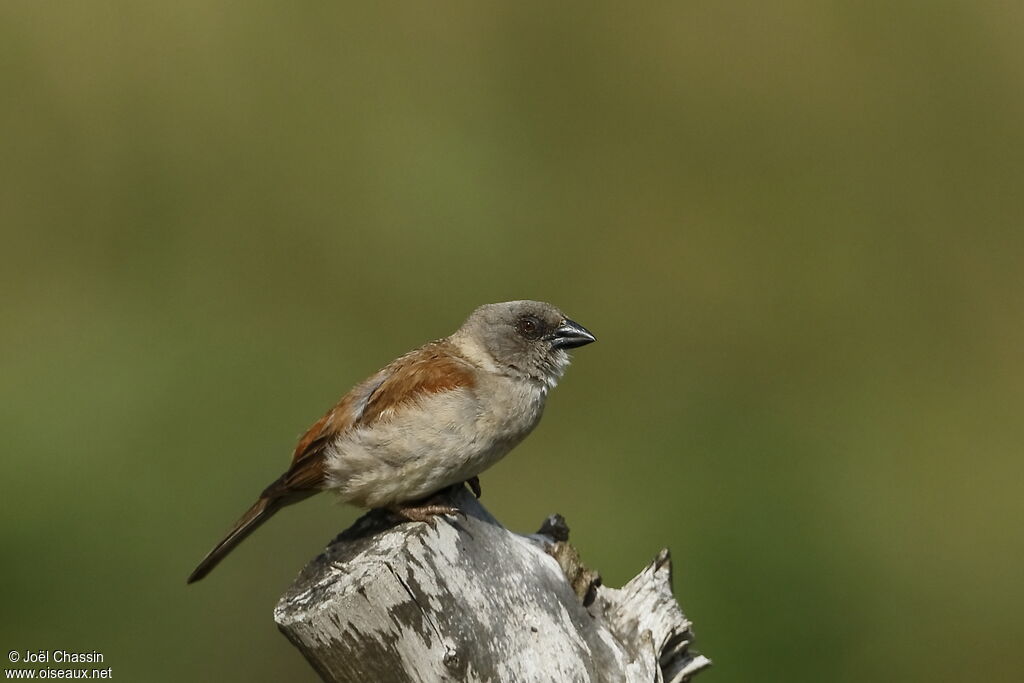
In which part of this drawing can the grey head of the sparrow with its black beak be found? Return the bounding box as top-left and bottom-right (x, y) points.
(453, 301), (596, 387)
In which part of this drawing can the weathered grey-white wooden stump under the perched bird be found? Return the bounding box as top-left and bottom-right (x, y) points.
(274, 487), (711, 683)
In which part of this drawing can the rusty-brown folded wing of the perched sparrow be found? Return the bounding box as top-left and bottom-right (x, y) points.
(263, 340), (474, 496)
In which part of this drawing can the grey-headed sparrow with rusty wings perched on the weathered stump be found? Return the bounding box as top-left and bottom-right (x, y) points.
(187, 300), (596, 584)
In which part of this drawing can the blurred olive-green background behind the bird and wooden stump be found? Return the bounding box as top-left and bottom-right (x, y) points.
(0, 0), (1024, 682)
